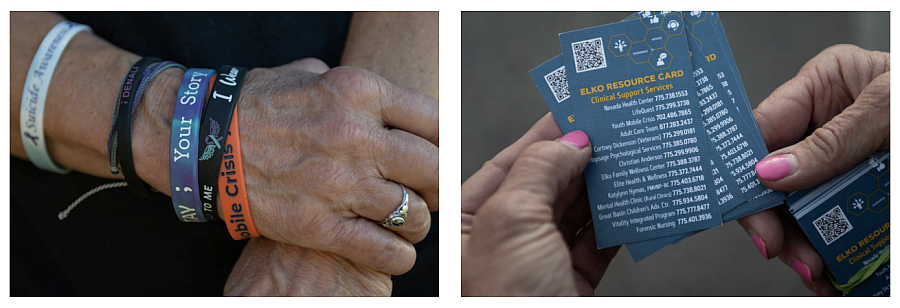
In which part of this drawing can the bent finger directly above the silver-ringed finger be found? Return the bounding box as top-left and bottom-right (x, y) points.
(375, 129), (440, 211)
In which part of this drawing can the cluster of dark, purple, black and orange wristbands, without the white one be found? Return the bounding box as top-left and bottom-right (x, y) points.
(108, 58), (259, 240)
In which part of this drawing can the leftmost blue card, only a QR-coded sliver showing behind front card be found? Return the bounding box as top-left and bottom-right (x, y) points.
(528, 55), (575, 134)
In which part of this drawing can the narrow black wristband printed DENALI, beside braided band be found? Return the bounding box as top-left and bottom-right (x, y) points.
(116, 57), (162, 197)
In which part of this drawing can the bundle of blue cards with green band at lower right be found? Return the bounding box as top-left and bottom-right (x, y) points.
(788, 152), (891, 284)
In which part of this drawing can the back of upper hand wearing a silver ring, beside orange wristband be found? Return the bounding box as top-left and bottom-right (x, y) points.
(229, 62), (438, 275)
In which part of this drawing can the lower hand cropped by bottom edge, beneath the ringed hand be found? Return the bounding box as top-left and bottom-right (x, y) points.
(225, 237), (391, 296)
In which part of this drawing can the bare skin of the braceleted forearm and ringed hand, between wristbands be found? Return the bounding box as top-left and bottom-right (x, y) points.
(10, 12), (439, 294)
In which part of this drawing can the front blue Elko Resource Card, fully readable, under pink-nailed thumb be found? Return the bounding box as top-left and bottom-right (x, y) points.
(560, 14), (722, 248)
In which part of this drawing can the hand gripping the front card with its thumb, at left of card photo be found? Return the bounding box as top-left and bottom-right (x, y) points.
(462, 114), (619, 296)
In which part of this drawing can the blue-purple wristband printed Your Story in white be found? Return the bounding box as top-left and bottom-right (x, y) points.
(169, 68), (216, 222)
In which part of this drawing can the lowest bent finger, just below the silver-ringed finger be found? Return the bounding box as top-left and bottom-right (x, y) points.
(323, 217), (416, 275)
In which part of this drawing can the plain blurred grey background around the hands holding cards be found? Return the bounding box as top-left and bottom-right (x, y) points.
(462, 12), (890, 296)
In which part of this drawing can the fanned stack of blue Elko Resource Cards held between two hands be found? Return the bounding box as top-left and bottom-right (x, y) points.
(530, 11), (785, 262)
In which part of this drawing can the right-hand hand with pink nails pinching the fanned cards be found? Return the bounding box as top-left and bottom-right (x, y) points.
(738, 45), (891, 295)
